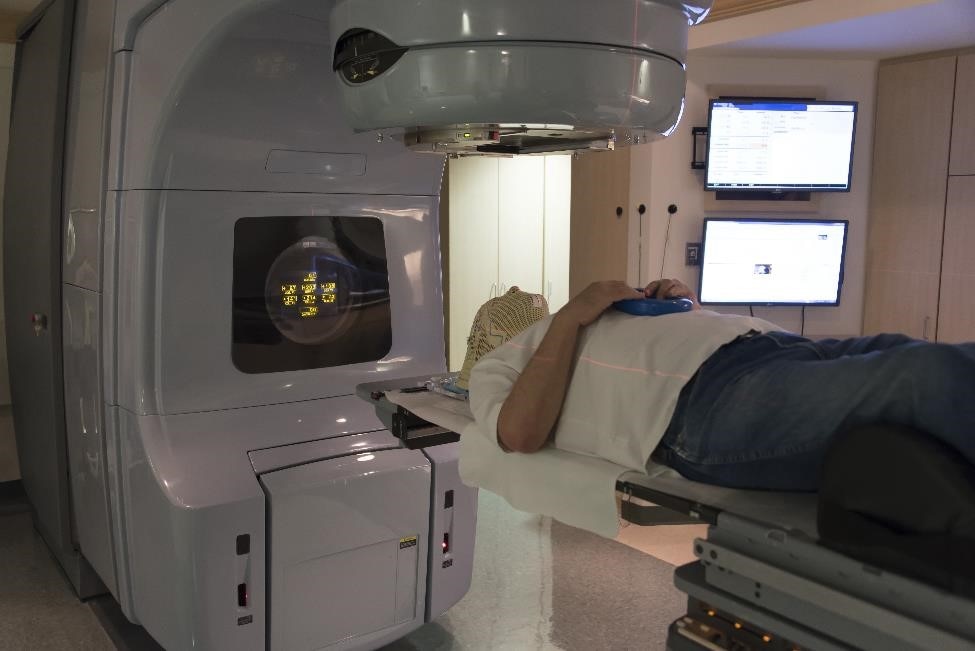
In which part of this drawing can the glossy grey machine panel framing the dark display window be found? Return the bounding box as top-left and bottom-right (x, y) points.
(117, 192), (445, 416)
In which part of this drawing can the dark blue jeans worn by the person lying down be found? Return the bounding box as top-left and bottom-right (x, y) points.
(653, 332), (975, 491)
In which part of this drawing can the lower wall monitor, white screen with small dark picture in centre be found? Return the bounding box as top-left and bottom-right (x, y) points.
(698, 218), (848, 305)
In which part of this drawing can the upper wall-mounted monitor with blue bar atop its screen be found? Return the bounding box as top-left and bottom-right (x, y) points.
(704, 98), (857, 193)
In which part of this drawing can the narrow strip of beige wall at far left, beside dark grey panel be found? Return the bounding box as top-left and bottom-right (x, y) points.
(0, 39), (20, 482)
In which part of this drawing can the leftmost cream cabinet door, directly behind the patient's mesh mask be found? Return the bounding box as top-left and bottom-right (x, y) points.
(447, 157), (499, 371)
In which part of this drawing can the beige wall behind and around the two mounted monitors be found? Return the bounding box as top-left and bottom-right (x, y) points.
(631, 55), (877, 335)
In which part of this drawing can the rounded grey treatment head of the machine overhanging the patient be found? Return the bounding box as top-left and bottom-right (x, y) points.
(332, 0), (712, 154)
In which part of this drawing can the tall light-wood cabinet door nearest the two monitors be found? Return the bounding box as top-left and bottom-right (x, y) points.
(863, 57), (955, 339)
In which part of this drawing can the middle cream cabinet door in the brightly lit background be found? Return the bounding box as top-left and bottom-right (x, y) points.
(498, 156), (545, 294)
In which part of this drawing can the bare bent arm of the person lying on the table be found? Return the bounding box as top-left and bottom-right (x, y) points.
(498, 281), (642, 452)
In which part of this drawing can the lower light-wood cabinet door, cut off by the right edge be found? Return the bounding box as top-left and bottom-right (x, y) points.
(938, 176), (975, 342)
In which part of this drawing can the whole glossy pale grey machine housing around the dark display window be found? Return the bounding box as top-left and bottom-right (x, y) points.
(64, 1), (476, 649)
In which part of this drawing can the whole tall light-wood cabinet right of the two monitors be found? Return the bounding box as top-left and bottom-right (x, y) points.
(863, 56), (975, 341)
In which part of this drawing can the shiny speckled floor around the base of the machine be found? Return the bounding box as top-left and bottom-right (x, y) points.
(0, 491), (702, 651)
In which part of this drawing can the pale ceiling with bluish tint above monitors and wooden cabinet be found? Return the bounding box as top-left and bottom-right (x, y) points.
(689, 0), (975, 59)
